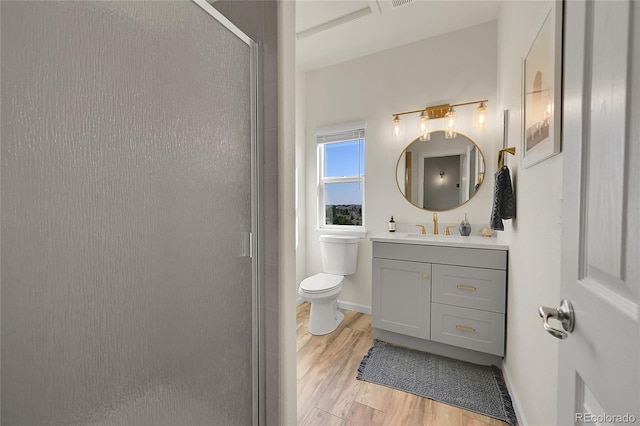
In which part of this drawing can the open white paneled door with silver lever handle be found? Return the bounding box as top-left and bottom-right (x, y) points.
(549, 0), (640, 425)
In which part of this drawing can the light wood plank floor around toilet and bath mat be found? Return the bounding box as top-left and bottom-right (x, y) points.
(296, 302), (506, 426)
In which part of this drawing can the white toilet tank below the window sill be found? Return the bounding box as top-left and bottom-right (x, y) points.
(320, 235), (360, 275)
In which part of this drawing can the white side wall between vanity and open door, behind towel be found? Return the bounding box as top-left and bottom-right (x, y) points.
(498, 1), (563, 425)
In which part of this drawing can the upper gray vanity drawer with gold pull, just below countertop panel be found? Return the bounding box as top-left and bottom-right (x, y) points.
(431, 265), (507, 314)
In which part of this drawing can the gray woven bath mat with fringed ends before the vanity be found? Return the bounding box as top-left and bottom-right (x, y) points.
(357, 340), (516, 426)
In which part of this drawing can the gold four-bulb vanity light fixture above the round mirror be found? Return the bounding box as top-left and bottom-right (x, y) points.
(392, 99), (489, 141)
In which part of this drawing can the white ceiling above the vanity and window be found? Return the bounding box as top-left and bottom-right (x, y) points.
(296, 0), (501, 71)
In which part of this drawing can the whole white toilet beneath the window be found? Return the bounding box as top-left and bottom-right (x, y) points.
(298, 235), (360, 336)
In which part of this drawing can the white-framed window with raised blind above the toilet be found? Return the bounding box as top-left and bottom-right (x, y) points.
(316, 123), (365, 231)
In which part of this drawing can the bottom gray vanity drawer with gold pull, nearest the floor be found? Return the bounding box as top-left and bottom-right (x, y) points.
(431, 303), (504, 356)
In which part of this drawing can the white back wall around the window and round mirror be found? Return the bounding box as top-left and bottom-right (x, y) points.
(303, 21), (502, 309)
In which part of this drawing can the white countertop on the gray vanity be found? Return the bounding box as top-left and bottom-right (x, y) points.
(371, 232), (509, 250)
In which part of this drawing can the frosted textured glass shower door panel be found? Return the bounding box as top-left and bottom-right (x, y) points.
(0, 1), (258, 425)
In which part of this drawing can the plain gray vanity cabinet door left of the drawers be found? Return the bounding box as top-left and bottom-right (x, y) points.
(372, 258), (431, 339)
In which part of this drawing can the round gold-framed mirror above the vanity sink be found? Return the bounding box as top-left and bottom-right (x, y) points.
(396, 130), (485, 211)
